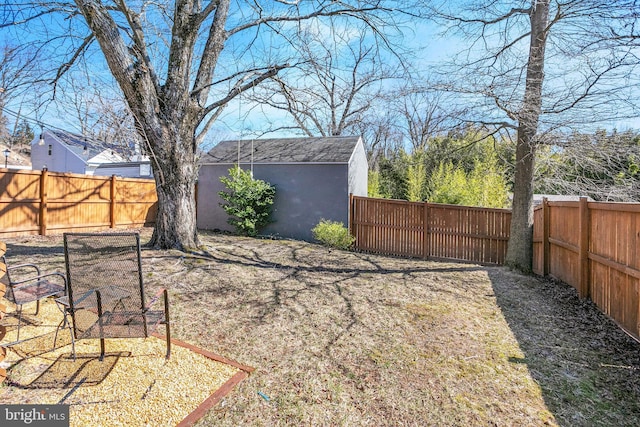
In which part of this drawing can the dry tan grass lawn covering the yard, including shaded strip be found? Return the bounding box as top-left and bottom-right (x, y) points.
(4, 229), (640, 426)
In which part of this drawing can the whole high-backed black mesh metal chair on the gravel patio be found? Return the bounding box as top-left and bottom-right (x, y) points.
(56, 233), (171, 360)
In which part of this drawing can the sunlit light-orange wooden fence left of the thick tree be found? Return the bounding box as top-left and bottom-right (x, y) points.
(0, 170), (157, 237)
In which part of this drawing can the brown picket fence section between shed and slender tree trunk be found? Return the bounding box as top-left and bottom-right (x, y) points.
(349, 196), (511, 264)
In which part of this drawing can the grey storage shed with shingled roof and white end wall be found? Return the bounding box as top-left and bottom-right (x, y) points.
(197, 136), (368, 241)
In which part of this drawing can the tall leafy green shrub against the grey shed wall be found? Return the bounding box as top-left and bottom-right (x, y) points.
(218, 166), (276, 236)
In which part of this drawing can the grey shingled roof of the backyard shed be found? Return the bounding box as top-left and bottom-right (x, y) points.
(200, 136), (360, 164)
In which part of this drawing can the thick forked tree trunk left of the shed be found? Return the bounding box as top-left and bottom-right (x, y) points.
(76, 0), (221, 250)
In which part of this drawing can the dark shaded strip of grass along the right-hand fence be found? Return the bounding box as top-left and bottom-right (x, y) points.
(487, 268), (640, 426)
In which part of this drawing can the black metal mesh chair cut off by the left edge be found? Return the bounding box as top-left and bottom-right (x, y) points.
(0, 256), (66, 346)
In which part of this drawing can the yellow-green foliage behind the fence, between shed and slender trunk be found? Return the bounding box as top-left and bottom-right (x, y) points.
(369, 130), (512, 208)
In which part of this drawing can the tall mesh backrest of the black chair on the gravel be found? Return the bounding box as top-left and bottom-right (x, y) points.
(64, 232), (145, 326)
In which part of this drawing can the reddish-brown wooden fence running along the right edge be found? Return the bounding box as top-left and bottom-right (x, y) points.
(533, 198), (640, 339)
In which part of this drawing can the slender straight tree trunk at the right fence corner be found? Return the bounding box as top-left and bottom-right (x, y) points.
(505, 0), (549, 272)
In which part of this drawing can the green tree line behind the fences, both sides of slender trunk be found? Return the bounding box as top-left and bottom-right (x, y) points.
(369, 128), (640, 208)
